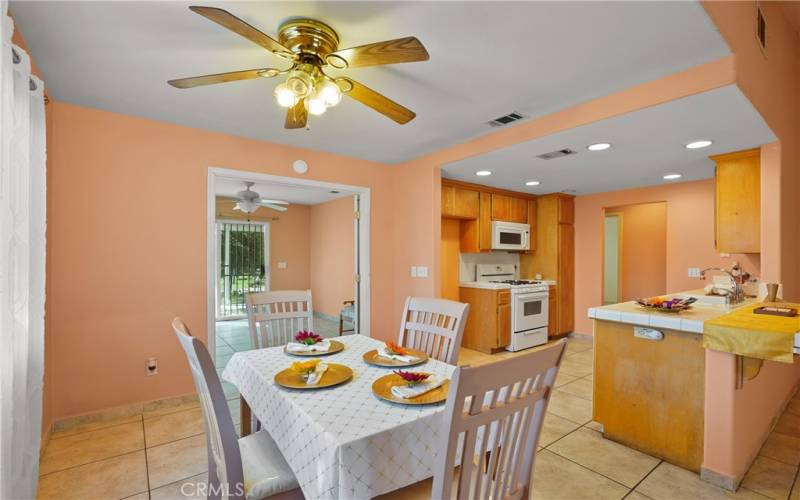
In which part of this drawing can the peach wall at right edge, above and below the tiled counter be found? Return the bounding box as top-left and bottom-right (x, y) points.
(703, 1), (800, 481)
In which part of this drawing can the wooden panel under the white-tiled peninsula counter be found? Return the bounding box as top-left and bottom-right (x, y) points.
(592, 320), (705, 472)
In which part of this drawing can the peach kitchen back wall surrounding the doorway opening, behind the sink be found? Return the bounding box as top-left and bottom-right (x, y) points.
(575, 179), (760, 334)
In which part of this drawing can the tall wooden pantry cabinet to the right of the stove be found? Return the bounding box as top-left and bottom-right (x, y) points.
(520, 193), (575, 335)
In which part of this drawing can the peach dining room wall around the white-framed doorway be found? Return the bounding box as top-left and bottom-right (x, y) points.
(47, 102), (404, 418)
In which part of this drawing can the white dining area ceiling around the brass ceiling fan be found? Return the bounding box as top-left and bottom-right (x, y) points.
(11, 1), (730, 163)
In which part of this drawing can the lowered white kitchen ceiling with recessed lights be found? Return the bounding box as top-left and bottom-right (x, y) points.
(442, 85), (776, 194)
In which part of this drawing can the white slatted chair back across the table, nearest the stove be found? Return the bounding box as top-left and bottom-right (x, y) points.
(398, 297), (469, 365)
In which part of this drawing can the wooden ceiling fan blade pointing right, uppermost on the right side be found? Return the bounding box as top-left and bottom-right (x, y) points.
(326, 36), (430, 69)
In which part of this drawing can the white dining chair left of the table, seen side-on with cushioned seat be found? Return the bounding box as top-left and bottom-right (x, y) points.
(172, 318), (303, 500)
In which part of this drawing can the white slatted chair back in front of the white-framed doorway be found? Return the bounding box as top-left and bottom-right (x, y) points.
(245, 290), (314, 349)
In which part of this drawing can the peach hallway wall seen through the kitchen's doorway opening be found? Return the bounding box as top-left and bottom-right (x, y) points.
(608, 202), (667, 302)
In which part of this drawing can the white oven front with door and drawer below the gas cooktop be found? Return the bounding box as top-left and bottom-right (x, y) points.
(506, 289), (548, 351)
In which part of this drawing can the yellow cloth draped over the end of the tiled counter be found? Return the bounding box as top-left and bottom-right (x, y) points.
(703, 303), (800, 363)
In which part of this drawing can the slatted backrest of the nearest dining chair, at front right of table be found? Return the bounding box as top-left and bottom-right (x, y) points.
(432, 340), (566, 500)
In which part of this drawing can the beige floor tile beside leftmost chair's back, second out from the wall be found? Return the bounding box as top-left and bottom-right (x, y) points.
(147, 434), (208, 489)
